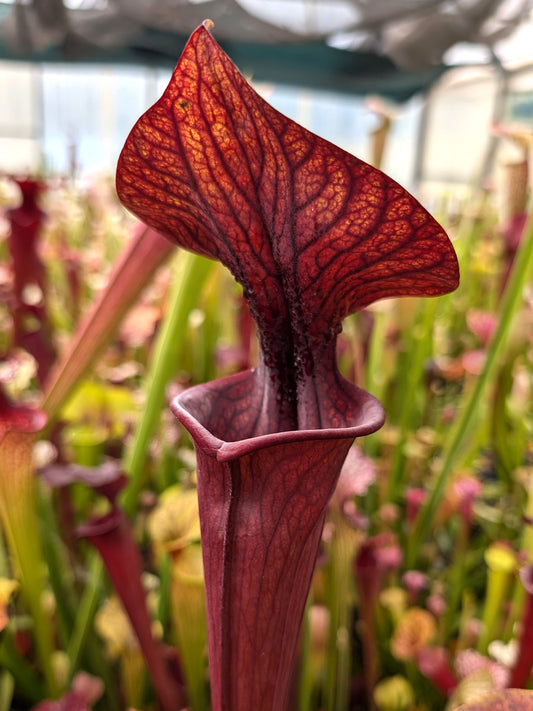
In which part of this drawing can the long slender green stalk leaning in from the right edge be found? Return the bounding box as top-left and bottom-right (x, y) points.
(406, 204), (533, 568)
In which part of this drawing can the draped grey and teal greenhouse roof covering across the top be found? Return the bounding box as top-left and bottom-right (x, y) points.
(0, 0), (532, 101)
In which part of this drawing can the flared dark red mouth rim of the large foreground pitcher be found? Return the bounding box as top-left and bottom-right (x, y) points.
(170, 370), (385, 462)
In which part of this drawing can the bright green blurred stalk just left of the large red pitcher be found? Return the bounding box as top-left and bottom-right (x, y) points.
(122, 252), (214, 515)
